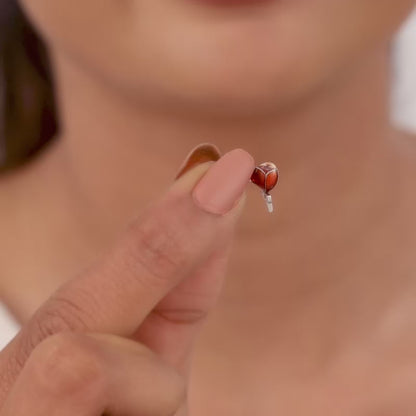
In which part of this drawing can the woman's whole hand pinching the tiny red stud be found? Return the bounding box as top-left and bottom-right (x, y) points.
(0, 149), (254, 416)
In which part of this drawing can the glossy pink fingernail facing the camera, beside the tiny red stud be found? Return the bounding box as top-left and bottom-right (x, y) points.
(192, 149), (255, 215)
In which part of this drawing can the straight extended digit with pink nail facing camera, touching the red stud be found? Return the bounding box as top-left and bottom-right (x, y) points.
(0, 145), (254, 400)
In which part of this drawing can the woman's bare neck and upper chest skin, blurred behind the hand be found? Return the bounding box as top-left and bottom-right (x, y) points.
(0, 2), (416, 416)
